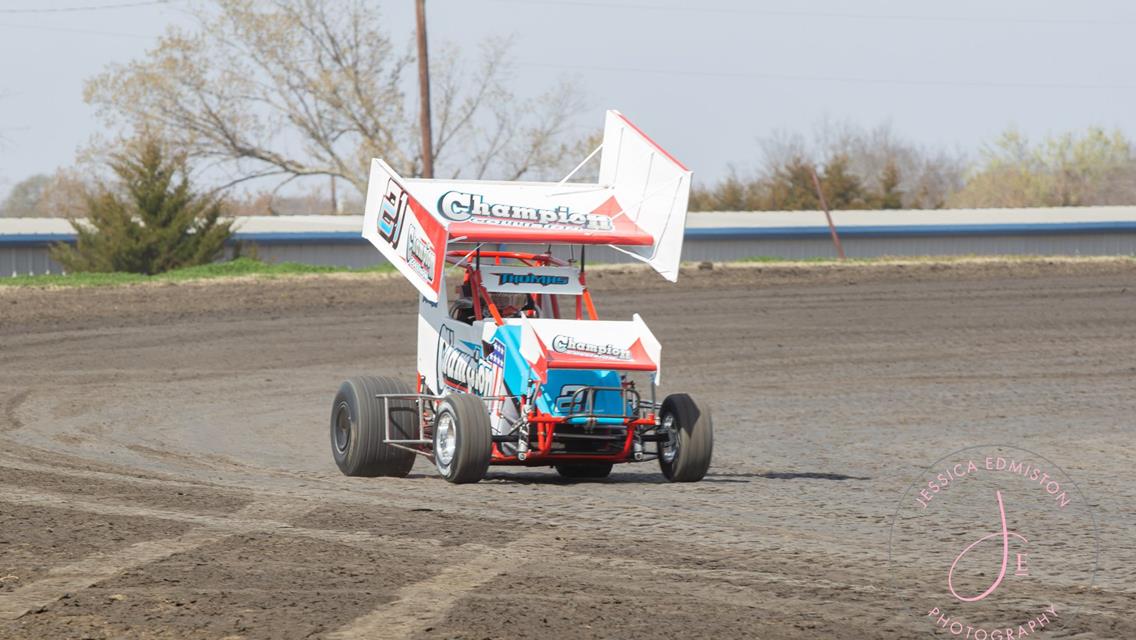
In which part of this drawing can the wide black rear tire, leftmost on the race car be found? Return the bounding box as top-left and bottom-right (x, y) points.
(331, 376), (421, 477)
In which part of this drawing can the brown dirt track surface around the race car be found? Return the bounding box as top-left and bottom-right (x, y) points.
(0, 263), (1136, 639)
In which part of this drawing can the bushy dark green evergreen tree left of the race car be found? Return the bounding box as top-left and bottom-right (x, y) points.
(51, 138), (232, 274)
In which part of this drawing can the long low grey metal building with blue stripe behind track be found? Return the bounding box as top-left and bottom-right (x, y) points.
(0, 206), (1136, 276)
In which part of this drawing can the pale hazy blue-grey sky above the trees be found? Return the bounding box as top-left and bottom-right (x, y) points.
(0, 0), (1136, 197)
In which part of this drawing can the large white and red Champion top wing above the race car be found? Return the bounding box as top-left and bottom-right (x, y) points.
(364, 110), (691, 285)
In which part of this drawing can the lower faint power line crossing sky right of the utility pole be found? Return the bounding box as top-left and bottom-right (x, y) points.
(518, 63), (1136, 90)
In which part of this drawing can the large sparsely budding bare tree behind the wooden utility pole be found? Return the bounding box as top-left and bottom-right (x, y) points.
(85, 0), (578, 202)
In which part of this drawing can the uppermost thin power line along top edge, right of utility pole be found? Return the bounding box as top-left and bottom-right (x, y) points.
(494, 0), (1136, 26)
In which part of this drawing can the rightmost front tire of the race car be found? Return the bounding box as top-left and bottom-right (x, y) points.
(659, 393), (713, 482)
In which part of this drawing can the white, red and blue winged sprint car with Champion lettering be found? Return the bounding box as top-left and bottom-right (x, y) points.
(331, 111), (713, 483)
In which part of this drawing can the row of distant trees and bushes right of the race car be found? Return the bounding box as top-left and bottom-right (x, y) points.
(690, 125), (1136, 211)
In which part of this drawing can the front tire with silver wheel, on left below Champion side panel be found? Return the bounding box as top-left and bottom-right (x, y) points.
(434, 393), (493, 484)
